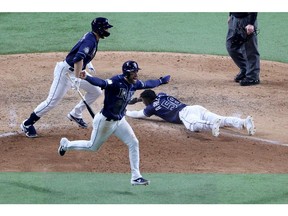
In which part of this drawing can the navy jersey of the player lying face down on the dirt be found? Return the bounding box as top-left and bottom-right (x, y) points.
(144, 93), (187, 124)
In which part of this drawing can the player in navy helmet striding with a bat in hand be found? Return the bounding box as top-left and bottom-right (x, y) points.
(20, 17), (113, 138)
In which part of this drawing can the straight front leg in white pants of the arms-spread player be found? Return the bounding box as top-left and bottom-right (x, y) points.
(114, 117), (142, 179)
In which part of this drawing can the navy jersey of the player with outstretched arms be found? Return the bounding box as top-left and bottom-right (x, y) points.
(86, 74), (161, 120)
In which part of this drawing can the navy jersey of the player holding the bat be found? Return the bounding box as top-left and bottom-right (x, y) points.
(65, 32), (98, 70)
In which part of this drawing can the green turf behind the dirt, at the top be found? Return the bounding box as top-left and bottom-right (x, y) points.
(0, 12), (288, 62)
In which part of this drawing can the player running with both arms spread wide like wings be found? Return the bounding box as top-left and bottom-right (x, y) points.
(58, 61), (170, 185)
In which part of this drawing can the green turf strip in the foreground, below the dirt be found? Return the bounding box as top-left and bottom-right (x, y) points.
(0, 173), (288, 204)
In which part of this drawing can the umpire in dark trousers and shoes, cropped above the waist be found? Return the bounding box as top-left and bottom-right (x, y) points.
(226, 12), (260, 86)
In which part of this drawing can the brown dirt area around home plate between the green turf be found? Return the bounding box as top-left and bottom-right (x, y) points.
(0, 52), (288, 173)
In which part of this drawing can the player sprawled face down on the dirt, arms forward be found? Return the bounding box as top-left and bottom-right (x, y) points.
(126, 89), (256, 137)
